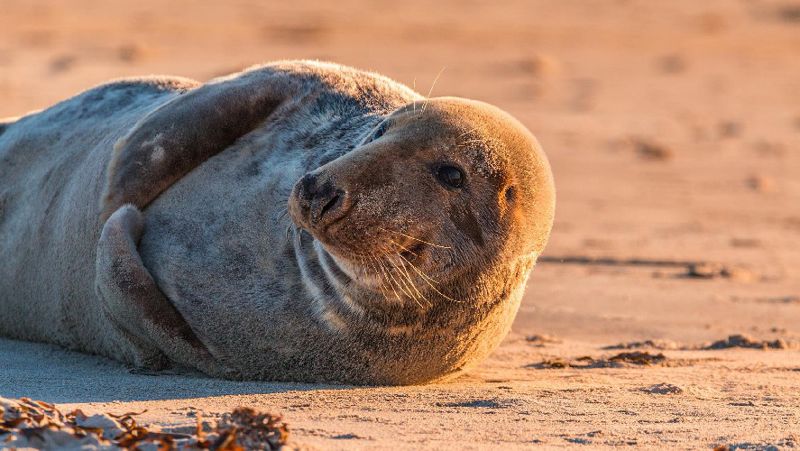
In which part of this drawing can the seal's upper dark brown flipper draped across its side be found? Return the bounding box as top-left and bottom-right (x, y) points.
(100, 68), (302, 220)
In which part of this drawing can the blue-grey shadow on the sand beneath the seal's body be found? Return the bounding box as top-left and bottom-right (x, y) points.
(0, 338), (352, 403)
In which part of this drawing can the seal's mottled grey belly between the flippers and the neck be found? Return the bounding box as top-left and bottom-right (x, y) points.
(139, 118), (368, 374)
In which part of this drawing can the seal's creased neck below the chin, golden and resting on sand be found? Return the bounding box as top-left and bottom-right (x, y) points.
(294, 228), (530, 384)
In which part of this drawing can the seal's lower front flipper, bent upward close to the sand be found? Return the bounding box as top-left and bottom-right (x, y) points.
(95, 205), (230, 376)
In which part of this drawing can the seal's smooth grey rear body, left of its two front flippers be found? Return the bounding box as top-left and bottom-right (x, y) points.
(0, 79), (196, 356)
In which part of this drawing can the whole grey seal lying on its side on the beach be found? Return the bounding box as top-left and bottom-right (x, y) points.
(0, 61), (555, 384)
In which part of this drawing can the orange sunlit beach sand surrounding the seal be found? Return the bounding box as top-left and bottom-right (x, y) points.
(0, 0), (800, 449)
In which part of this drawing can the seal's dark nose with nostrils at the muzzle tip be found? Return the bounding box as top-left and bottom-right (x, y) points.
(297, 173), (349, 227)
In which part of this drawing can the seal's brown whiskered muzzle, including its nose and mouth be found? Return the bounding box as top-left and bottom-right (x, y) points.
(288, 167), (449, 300)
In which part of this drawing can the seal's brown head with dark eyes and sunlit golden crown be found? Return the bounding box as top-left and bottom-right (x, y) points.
(289, 97), (555, 301)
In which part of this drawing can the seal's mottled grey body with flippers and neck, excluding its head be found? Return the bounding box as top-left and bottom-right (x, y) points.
(0, 62), (552, 384)
